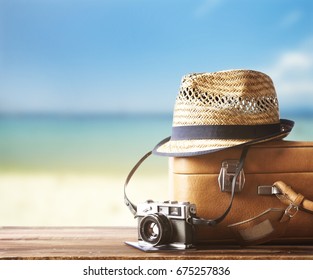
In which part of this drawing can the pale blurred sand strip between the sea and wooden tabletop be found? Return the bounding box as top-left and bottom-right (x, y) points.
(0, 173), (168, 226)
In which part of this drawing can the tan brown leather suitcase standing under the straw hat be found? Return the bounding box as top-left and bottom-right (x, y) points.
(169, 140), (313, 245)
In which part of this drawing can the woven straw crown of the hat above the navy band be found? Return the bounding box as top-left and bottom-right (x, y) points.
(173, 70), (279, 126)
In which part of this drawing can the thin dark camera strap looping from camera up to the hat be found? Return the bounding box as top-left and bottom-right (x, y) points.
(124, 146), (248, 226)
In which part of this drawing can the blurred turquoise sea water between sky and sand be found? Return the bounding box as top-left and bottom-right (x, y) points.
(0, 112), (313, 174)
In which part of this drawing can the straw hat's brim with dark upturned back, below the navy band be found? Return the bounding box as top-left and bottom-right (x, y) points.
(152, 120), (294, 157)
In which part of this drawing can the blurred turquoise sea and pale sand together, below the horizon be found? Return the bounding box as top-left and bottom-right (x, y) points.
(0, 114), (313, 226)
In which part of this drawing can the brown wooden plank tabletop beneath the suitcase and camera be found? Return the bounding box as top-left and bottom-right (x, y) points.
(0, 227), (313, 260)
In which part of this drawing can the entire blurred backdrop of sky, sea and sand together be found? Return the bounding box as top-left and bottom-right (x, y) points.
(0, 0), (313, 229)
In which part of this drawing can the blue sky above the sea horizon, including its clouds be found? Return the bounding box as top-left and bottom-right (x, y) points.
(0, 0), (313, 114)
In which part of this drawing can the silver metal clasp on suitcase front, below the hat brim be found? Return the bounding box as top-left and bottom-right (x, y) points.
(218, 159), (245, 192)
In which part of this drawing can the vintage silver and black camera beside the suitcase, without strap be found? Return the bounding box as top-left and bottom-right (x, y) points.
(136, 200), (196, 248)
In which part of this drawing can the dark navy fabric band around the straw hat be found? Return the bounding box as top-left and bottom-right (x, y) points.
(171, 123), (281, 140)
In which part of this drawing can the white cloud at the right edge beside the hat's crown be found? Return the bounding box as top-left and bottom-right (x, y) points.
(266, 40), (313, 112)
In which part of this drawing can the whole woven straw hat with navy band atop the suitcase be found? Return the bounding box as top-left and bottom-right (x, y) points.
(153, 70), (294, 157)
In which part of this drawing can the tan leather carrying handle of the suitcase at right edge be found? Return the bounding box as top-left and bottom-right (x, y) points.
(274, 181), (313, 214)
